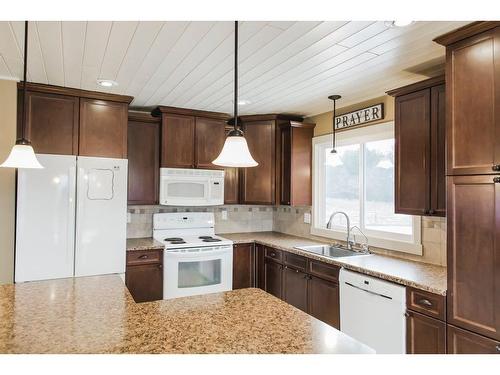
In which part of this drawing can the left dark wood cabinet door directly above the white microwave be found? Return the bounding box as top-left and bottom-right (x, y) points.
(161, 113), (195, 168)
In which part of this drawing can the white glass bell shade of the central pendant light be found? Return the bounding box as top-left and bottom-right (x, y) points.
(212, 135), (259, 168)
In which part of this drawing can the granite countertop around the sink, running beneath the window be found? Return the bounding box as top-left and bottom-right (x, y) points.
(221, 232), (446, 295)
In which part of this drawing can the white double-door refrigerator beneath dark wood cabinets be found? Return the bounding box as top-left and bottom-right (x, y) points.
(15, 154), (127, 282)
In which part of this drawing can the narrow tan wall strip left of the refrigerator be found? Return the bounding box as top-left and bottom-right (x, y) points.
(0, 80), (17, 284)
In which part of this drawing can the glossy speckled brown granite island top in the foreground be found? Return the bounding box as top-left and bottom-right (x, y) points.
(0, 275), (373, 353)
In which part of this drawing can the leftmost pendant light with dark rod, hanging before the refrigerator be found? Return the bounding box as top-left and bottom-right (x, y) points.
(0, 21), (43, 168)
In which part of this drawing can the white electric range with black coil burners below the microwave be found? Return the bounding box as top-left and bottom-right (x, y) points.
(153, 212), (233, 299)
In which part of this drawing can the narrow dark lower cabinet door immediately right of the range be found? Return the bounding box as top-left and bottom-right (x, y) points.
(233, 243), (255, 289)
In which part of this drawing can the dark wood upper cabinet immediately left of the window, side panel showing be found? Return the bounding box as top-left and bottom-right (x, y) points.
(276, 121), (315, 206)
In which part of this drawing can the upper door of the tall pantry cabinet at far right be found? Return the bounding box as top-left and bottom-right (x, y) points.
(446, 28), (500, 175)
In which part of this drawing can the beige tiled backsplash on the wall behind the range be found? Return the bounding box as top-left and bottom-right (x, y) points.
(127, 205), (273, 238)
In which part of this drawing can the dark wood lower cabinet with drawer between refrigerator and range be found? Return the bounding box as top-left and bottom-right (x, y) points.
(125, 249), (163, 302)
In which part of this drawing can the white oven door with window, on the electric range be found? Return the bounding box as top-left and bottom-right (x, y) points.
(163, 246), (233, 299)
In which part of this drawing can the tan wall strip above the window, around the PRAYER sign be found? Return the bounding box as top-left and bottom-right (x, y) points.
(305, 95), (394, 137)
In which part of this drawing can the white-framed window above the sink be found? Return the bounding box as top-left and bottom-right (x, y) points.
(311, 122), (422, 254)
